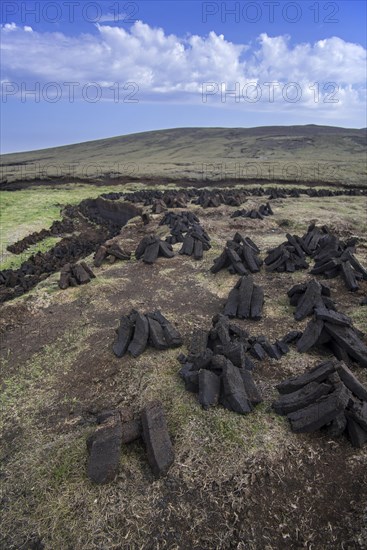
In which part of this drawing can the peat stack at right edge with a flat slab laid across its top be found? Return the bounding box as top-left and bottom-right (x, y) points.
(297, 305), (367, 368)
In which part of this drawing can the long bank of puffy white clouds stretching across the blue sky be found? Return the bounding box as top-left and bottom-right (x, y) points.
(1, 21), (366, 123)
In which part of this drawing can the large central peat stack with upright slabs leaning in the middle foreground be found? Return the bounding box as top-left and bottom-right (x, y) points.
(179, 316), (262, 414)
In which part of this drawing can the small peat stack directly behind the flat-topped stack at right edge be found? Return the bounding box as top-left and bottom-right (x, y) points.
(287, 279), (336, 321)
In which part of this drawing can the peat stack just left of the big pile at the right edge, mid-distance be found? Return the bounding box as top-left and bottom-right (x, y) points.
(264, 233), (308, 273)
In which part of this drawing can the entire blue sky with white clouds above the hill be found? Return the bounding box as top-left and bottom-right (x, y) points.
(1, 0), (366, 152)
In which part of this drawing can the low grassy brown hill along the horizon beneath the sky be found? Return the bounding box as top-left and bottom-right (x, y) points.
(1, 125), (367, 189)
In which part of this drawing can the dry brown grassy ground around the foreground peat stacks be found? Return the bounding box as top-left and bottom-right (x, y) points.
(0, 193), (367, 550)
